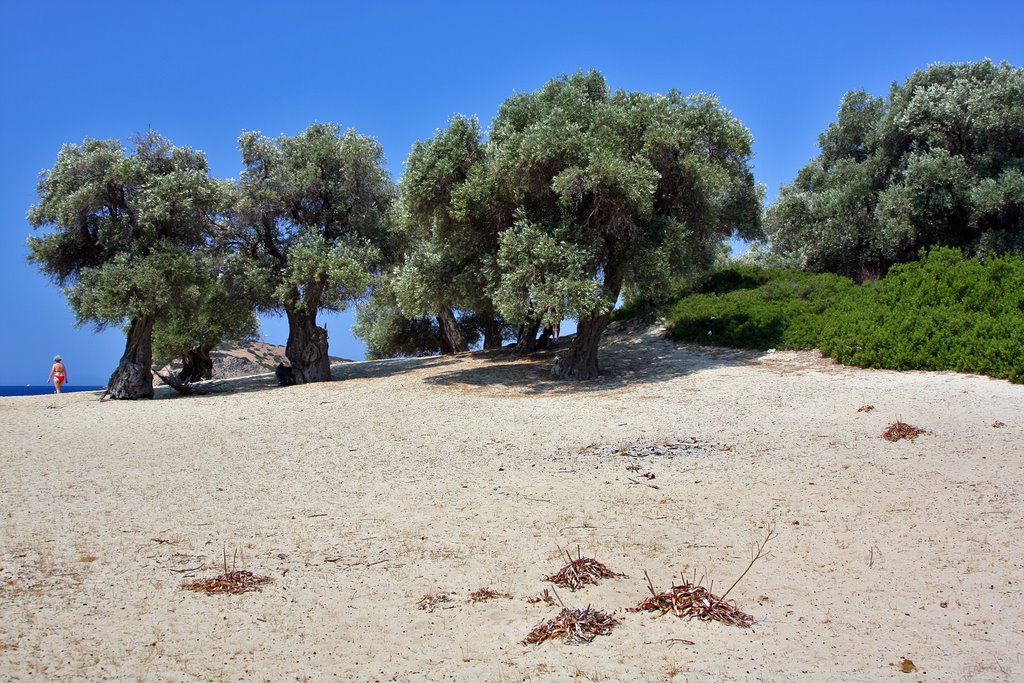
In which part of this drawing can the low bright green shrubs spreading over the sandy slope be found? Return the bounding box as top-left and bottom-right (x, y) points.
(616, 248), (1024, 382)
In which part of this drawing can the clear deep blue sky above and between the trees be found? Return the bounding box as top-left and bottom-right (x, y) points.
(0, 0), (1024, 385)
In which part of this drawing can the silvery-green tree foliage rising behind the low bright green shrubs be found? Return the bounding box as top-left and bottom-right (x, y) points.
(766, 60), (1024, 278)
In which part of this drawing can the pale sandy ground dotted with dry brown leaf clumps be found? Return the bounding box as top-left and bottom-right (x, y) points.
(0, 329), (1024, 681)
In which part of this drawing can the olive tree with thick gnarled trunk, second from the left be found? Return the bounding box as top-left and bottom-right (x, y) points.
(234, 124), (394, 383)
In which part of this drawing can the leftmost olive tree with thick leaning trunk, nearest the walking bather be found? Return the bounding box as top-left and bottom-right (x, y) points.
(29, 132), (225, 398)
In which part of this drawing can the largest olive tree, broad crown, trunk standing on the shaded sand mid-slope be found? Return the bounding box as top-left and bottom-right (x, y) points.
(486, 72), (760, 379)
